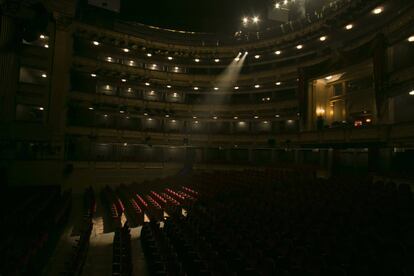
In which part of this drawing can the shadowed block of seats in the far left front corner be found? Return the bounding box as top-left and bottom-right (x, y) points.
(0, 187), (71, 276)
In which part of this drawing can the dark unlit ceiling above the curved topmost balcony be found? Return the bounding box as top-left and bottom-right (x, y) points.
(121, 0), (272, 33)
